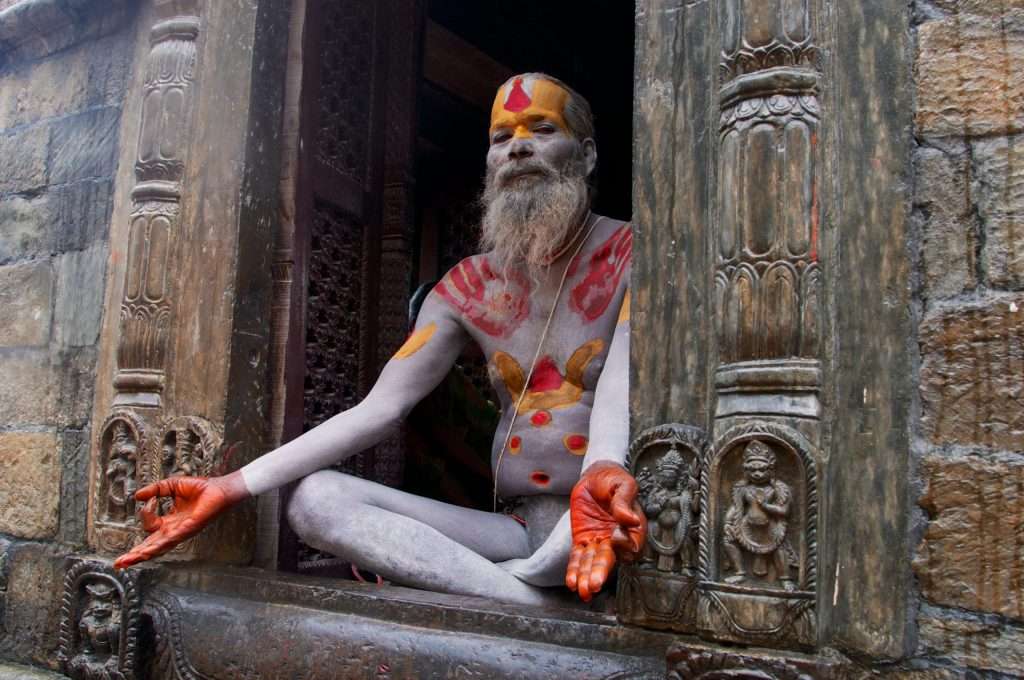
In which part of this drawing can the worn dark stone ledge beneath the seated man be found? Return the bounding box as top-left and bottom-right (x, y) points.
(142, 565), (673, 679)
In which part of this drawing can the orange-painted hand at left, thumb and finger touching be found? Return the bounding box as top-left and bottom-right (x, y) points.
(114, 472), (249, 569)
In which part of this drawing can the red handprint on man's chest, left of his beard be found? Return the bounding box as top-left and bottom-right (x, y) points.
(434, 257), (529, 338)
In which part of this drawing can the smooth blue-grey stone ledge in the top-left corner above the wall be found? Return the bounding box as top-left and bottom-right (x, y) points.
(0, 0), (136, 69)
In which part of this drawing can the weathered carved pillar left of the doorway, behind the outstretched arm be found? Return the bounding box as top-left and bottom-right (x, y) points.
(90, 0), (287, 561)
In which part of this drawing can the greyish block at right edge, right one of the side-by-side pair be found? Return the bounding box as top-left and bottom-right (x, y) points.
(973, 135), (1024, 289)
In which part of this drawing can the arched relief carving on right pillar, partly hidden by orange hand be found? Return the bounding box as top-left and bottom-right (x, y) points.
(618, 424), (705, 632)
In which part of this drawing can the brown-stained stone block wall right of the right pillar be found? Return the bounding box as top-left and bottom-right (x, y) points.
(913, 0), (1024, 677)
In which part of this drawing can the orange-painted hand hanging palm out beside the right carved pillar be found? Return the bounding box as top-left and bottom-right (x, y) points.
(565, 461), (647, 602)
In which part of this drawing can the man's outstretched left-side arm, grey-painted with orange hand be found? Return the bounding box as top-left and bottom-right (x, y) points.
(115, 293), (469, 568)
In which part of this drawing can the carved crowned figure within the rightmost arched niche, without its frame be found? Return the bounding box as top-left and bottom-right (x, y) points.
(723, 440), (798, 591)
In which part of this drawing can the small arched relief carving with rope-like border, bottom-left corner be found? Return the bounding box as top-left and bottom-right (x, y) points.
(59, 561), (140, 680)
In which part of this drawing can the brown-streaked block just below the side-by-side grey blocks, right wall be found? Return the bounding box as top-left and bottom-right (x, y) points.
(920, 294), (1024, 451)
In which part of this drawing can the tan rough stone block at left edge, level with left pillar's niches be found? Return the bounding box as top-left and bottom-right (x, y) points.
(0, 432), (60, 539)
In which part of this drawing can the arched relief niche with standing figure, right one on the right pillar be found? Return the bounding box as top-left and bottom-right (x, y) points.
(697, 422), (818, 647)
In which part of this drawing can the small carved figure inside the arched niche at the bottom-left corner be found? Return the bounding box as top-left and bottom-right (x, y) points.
(68, 581), (121, 679)
